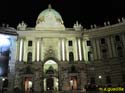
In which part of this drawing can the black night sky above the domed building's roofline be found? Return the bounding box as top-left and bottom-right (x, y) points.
(0, 0), (125, 27)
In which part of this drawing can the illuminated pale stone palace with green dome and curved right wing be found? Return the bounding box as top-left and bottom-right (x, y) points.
(0, 6), (125, 91)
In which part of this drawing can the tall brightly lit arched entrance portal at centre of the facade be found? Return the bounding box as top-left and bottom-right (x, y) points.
(43, 60), (58, 91)
